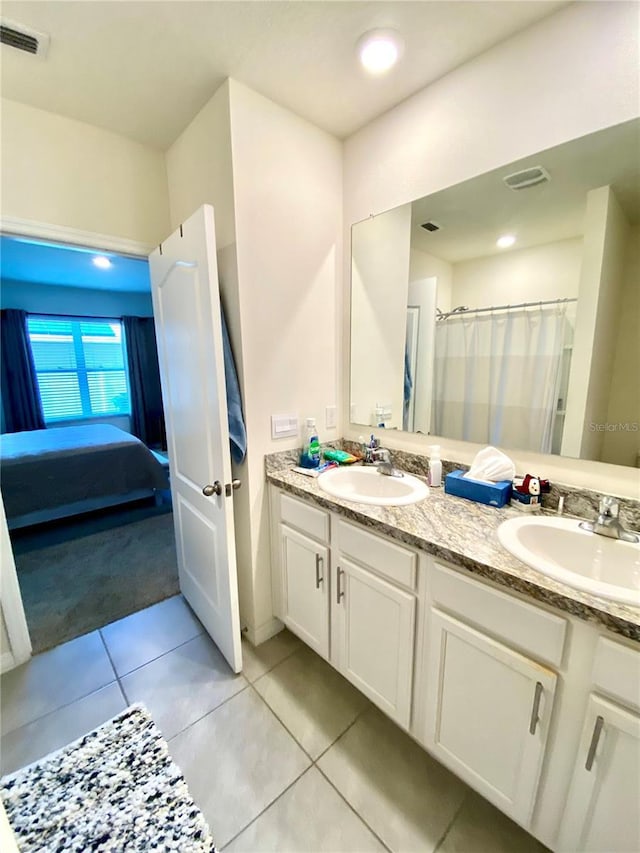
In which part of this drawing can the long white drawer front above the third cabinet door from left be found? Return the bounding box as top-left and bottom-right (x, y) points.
(430, 563), (567, 666)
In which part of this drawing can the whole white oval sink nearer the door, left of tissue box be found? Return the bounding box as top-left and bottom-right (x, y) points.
(318, 466), (429, 506)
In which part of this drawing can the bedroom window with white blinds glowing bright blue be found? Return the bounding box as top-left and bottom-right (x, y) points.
(27, 316), (131, 423)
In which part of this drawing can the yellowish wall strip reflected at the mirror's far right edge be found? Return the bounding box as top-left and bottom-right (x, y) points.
(601, 225), (640, 466)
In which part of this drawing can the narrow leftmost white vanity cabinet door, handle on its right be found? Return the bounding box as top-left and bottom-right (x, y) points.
(278, 524), (329, 659)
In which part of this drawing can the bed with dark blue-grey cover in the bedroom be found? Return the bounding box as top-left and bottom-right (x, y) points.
(0, 424), (169, 529)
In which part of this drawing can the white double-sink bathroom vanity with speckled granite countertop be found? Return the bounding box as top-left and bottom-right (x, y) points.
(267, 468), (640, 853)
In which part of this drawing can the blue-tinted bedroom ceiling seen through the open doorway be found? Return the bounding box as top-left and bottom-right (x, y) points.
(0, 236), (151, 293)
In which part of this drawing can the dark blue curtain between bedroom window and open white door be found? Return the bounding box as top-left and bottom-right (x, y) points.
(122, 317), (167, 450)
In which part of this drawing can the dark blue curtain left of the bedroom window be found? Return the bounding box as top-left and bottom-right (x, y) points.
(0, 308), (45, 432)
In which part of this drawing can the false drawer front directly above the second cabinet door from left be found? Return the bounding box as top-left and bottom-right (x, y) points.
(338, 521), (418, 589)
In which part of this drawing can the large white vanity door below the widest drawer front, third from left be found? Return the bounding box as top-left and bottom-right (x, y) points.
(425, 608), (556, 826)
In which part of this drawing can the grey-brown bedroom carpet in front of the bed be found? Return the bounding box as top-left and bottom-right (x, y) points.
(14, 512), (179, 654)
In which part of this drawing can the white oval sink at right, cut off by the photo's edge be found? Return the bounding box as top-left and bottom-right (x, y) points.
(498, 517), (640, 606)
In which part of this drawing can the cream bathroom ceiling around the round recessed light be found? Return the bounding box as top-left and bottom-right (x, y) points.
(0, 0), (567, 150)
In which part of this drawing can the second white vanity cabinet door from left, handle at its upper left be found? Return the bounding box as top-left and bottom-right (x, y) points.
(334, 557), (416, 728)
